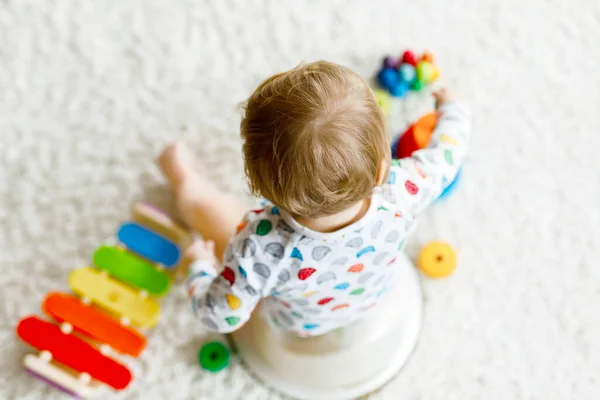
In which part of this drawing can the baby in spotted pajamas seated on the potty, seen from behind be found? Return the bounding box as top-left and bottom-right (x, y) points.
(160, 61), (471, 336)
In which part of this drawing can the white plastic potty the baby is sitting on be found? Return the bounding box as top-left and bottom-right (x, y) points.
(231, 253), (423, 400)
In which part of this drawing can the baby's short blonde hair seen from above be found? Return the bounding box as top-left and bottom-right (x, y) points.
(241, 61), (390, 217)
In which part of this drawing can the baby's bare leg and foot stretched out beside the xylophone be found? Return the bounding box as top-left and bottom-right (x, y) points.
(159, 143), (247, 259)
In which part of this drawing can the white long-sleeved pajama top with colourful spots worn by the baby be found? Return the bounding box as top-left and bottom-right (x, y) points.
(188, 103), (471, 336)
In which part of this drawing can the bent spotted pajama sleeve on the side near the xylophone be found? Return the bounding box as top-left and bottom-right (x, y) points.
(187, 214), (272, 333)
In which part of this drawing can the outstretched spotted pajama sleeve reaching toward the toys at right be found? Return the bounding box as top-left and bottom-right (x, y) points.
(384, 102), (471, 216)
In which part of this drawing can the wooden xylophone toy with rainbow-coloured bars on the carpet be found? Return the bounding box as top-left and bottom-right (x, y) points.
(16, 203), (192, 399)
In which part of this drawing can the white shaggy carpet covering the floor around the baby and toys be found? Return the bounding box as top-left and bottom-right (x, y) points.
(0, 0), (600, 400)
